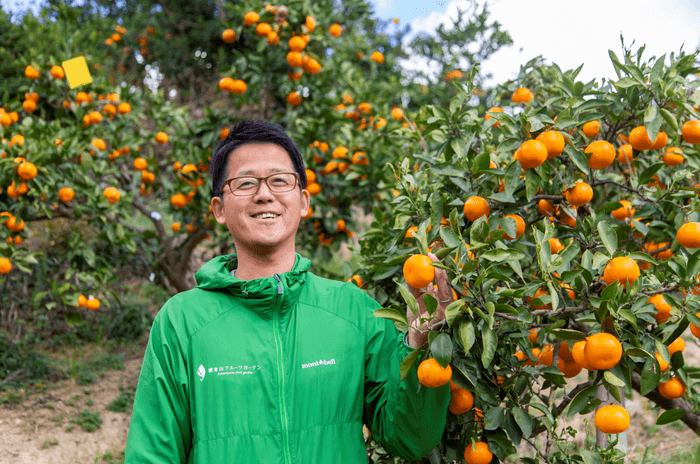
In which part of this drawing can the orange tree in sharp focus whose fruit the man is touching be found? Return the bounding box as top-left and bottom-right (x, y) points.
(357, 44), (700, 463)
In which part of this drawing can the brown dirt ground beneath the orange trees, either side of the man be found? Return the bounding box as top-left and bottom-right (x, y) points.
(0, 330), (700, 464)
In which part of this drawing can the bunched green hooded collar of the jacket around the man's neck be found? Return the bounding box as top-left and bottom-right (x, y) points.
(195, 253), (311, 320)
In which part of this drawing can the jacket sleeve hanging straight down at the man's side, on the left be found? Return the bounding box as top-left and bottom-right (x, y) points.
(124, 304), (192, 464)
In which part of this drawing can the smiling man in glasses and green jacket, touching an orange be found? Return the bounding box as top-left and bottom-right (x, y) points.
(125, 121), (450, 464)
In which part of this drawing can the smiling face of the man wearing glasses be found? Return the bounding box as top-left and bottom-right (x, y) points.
(211, 143), (310, 253)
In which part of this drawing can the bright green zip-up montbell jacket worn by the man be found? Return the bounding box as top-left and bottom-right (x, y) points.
(125, 253), (449, 464)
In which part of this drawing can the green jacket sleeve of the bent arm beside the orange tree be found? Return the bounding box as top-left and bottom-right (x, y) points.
(363, 297), (450, 460)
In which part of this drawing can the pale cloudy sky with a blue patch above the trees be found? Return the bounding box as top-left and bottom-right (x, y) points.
(370, 0), (700, 84)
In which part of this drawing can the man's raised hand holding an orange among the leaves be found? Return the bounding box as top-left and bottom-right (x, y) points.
(406, 253), (453, 348)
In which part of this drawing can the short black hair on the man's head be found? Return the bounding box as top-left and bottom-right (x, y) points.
(209, 119), (306, 197)
